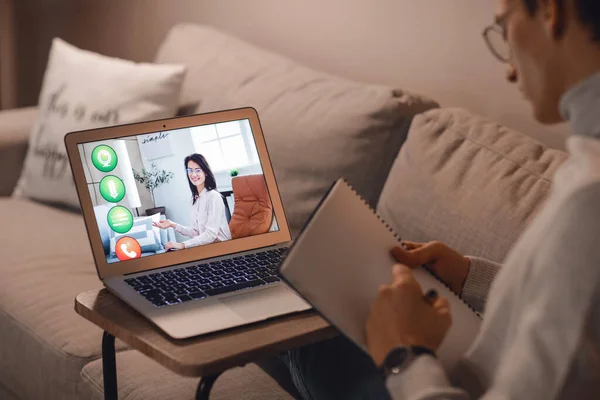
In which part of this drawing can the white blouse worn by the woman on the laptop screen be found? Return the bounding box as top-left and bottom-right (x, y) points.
(174, 189), (231, 248)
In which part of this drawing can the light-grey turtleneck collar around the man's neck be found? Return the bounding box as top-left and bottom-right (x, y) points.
(559, 72), (600, 138)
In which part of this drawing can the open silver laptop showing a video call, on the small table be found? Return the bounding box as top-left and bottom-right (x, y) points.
(65, 108), (311, 339)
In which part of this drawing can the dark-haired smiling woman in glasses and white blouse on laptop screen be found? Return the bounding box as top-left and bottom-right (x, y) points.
(153, 153), (231, 250)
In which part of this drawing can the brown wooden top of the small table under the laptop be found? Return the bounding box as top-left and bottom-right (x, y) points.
(75, 289), (337, 377)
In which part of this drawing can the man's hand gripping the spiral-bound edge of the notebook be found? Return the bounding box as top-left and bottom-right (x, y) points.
(392, 241), (471, 295)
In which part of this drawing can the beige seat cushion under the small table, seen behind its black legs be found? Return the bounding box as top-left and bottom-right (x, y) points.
(81, 350), (292, 400)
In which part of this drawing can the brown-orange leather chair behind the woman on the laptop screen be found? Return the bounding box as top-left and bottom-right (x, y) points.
(229, 174), (273, 239)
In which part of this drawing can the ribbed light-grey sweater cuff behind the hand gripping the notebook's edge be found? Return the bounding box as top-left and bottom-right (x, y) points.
(461, 256), (502, 313)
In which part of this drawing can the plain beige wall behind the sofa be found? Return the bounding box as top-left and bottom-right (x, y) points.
(16, 0), (567, 148)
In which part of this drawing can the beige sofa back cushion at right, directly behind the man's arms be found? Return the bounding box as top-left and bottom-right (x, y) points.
(378, 109), (567, 262)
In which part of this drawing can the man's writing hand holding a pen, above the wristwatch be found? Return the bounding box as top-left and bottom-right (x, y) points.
(366, 264), (452, 366)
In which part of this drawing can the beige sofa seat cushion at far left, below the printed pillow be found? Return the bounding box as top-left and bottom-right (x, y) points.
(0, 198), (129, 400)
